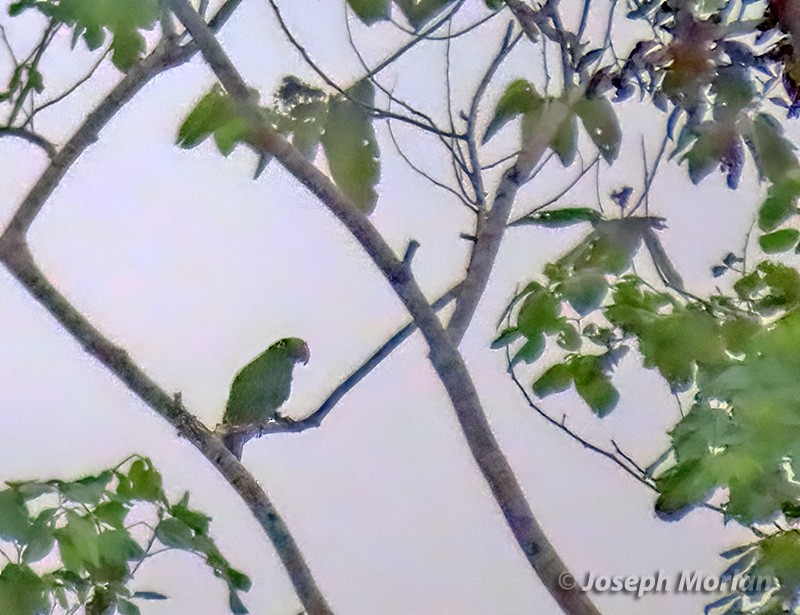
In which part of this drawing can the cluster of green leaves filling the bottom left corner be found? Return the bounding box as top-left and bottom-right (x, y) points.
(0, 455), (250, 615)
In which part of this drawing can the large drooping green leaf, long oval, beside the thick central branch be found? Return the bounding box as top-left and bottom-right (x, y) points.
(321, 81), (380, 213)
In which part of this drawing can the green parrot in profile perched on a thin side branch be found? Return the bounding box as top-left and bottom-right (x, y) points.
(222, 337), (310, 426)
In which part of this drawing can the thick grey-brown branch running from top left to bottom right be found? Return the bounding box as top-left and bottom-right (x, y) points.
(170, 0), (598, 615)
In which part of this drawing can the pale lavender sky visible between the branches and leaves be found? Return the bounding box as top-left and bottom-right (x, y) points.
(0, 0), (760, 615)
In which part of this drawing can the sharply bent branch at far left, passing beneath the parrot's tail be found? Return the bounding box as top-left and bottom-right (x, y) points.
(0, 0), (332, 615)
